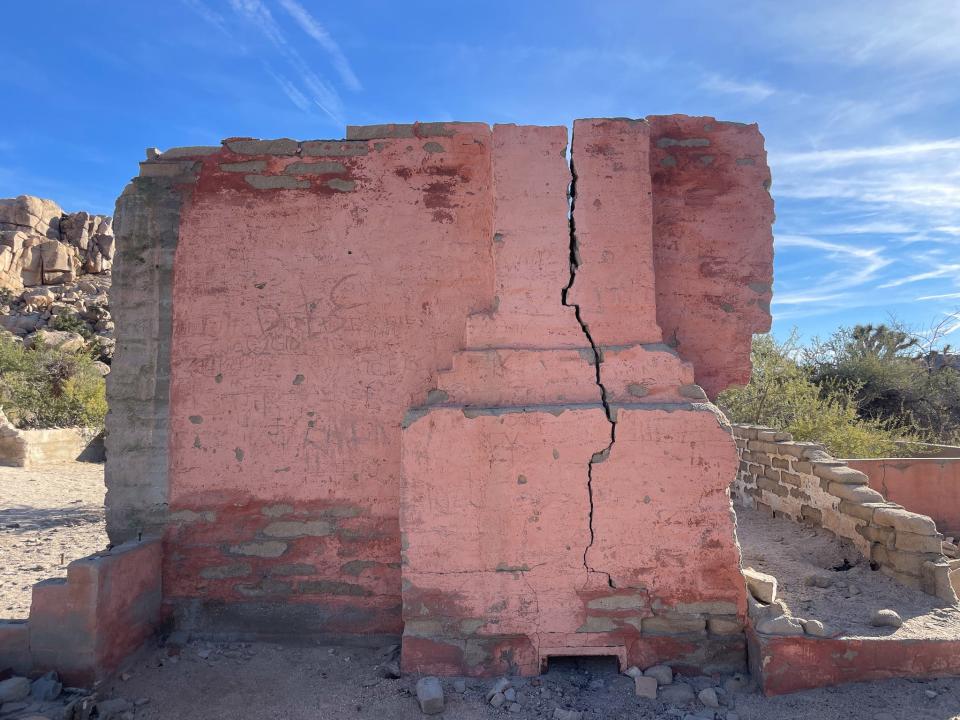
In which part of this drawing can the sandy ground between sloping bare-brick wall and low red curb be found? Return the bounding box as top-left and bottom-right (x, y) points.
(736, 507), (960, 639)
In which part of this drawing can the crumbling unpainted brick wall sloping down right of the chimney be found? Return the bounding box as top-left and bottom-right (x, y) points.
(731, 425), (960, 603)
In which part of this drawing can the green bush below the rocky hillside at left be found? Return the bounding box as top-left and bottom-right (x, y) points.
(0, 337), (107, 428)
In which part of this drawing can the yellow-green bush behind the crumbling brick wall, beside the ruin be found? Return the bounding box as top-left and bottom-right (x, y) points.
(717, 335), (919, 458)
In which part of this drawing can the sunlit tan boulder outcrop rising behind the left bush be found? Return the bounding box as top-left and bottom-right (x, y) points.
(0, 195), (116, 363)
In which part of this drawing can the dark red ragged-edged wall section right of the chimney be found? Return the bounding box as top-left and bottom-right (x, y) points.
(647, 115), (773, 398)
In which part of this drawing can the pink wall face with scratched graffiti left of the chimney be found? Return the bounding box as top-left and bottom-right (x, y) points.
(165, 125), (493, 633)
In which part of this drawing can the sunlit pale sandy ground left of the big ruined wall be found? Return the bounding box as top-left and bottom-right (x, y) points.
(0, 462), (107, 620)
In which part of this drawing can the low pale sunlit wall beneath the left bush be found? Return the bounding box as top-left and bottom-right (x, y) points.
(0, 420), (103, 468)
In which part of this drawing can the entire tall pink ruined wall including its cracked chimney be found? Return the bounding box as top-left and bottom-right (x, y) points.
(107, 116), (773, 672)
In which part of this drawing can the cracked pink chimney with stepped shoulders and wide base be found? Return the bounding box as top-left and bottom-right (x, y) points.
(400, 120), (746, 675)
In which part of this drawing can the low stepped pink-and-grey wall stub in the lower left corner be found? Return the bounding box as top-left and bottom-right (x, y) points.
(0, 539), (162, 686)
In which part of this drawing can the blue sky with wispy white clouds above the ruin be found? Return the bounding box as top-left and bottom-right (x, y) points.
(0, 0), (960, 344)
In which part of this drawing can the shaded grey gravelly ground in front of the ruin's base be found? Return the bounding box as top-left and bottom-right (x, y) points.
(92, 643), (960, 720)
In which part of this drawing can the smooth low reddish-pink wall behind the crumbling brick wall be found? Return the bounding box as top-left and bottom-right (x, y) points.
(846, 458), (960, 536)
